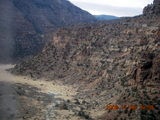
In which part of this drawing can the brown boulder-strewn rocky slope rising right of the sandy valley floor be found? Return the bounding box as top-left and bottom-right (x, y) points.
(11, 0), (160, 120)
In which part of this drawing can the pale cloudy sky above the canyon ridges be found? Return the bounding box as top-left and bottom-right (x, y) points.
(69, 0), (153, 16)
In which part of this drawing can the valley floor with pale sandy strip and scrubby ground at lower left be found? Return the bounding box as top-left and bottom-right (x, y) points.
(0, 65), (103, 120)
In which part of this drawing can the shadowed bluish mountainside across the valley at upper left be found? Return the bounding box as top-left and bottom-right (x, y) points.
(0, 0), (95, 61)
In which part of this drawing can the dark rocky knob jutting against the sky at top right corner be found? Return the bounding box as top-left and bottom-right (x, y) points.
(143, 0), (160, 15)
